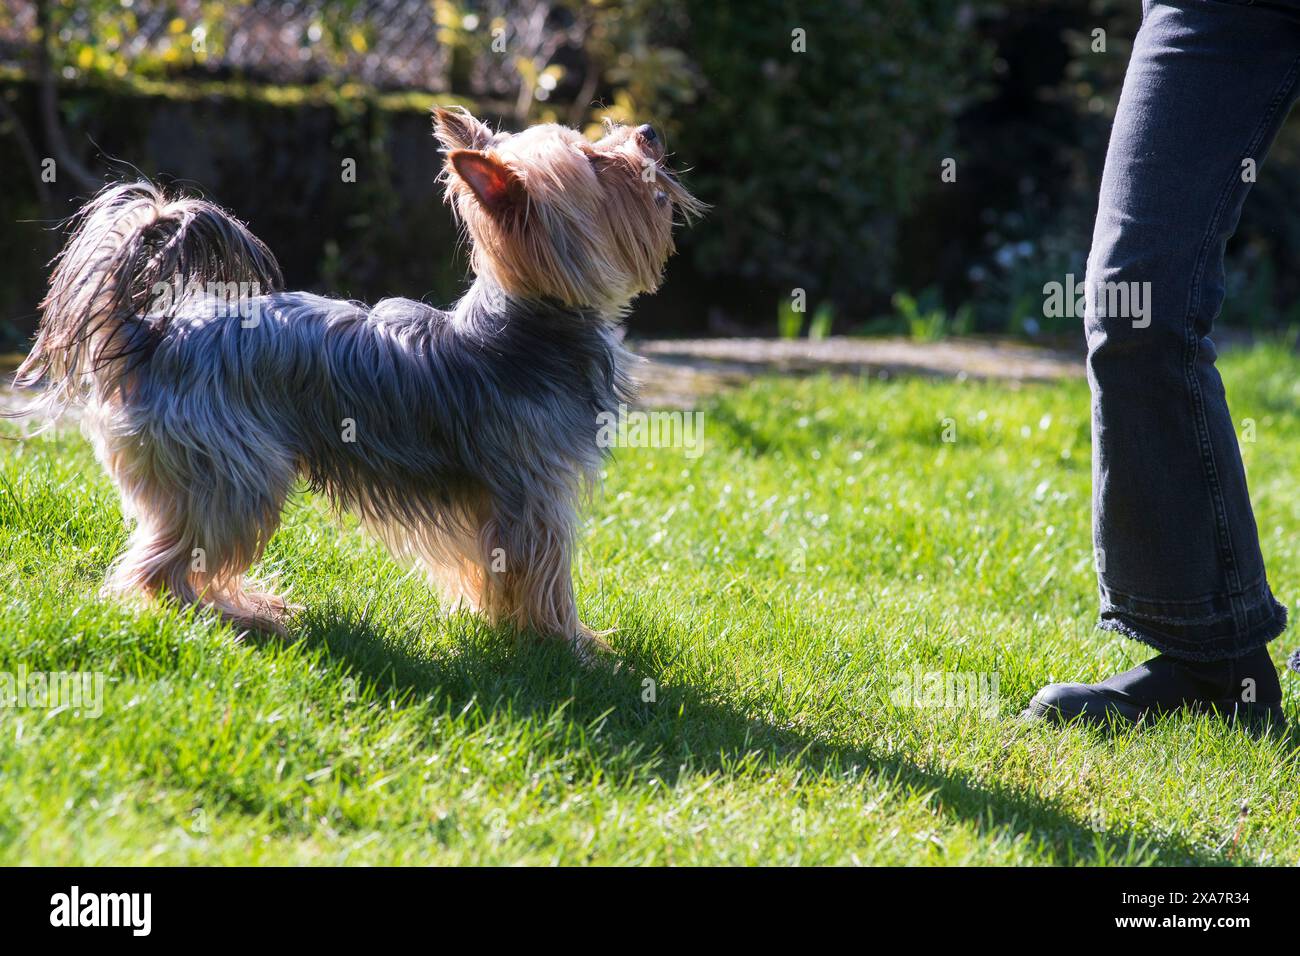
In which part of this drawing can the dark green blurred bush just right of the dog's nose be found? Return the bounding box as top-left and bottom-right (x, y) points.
(672, 0), (985, 311)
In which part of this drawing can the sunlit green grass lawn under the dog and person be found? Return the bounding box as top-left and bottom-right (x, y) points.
(0, 349), (1300, 864)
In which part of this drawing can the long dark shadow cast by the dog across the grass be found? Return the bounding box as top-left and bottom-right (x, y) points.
(296, 610), (1231, 865)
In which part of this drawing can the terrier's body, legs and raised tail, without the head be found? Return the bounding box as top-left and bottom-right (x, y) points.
(10, 183), (632, 644)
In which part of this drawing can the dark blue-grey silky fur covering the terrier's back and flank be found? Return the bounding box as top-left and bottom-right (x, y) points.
(142, 280), (632, 520)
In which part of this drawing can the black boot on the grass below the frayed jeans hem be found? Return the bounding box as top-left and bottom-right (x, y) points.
(1024, 648), (1286, 730)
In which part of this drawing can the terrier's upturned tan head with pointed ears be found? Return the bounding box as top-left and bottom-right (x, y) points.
(437, 111), (705, 316)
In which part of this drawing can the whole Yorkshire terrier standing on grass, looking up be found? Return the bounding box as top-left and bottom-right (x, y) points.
(16, 109), (703, 658)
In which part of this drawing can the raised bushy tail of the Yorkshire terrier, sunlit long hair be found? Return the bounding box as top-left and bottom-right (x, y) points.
(10, 181), (283, 420)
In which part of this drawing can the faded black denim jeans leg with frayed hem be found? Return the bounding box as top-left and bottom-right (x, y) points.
(1084, 0), (1300, 661)
